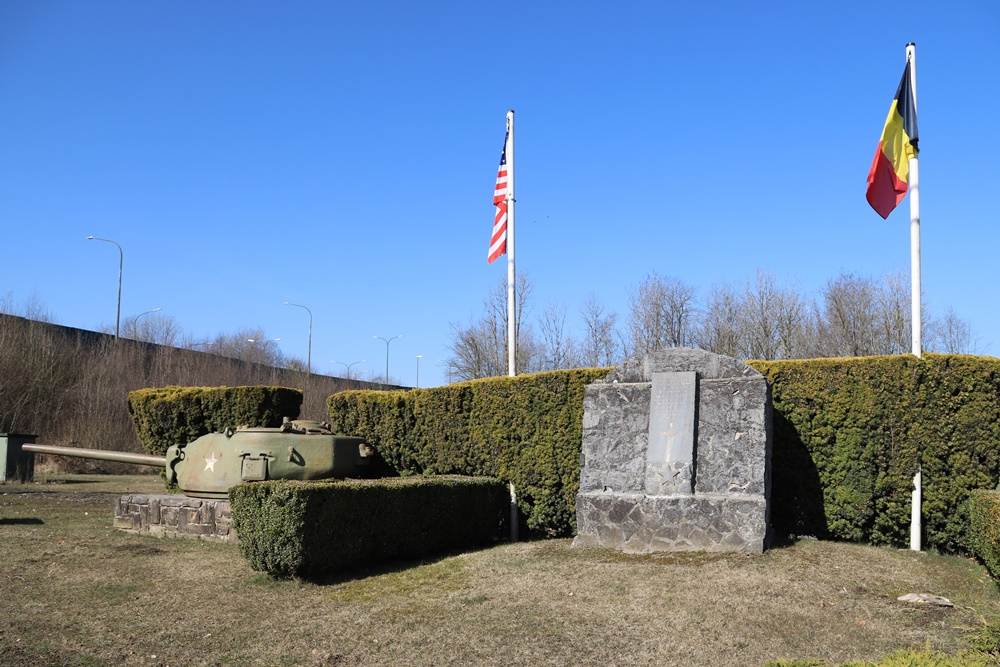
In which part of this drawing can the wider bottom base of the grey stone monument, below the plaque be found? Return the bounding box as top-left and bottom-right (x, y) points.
(573, 493), (768, 554)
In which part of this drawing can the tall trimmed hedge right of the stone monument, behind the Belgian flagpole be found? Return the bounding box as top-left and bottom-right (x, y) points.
(748, 354), (1000, 551)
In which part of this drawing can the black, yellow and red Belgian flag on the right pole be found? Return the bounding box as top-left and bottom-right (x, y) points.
(866, 61), (918, 218)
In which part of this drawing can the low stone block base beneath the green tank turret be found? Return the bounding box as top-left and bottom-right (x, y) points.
(115, 493), (237, 544)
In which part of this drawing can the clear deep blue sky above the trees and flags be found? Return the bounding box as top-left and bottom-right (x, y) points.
(0, 0), (1000, 386)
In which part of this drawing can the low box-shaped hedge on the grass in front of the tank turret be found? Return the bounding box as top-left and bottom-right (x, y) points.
(229, 476), (510, 577)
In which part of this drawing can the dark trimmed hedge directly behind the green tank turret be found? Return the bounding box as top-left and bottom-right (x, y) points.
(128, 387), (302, 456)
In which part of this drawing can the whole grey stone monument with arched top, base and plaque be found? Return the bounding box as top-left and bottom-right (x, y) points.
(573, 348), (771, 553)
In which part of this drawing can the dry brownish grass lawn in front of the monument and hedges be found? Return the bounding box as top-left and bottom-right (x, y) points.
(0, 477), (1000, 667)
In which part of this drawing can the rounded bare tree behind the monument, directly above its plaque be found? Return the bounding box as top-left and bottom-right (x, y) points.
(627, 271), (695, 355)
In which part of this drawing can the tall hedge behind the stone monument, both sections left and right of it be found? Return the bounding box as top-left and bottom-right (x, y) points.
(328, 354), (1000, 551)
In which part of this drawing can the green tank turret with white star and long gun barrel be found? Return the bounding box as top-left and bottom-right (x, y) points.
(22, 417), (374, 498)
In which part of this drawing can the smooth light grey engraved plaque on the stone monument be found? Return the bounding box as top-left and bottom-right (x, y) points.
(646, 372), (698, 464)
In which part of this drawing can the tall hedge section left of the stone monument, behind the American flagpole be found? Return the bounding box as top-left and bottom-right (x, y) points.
(328, 368), (611, 536)
